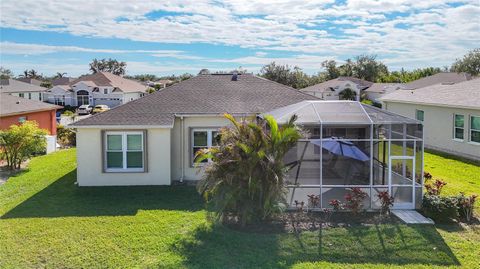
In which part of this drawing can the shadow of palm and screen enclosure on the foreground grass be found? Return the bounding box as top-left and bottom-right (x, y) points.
(173, 221), (460, 268)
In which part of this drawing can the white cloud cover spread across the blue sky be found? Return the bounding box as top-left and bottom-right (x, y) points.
(0, 0), (480, 69)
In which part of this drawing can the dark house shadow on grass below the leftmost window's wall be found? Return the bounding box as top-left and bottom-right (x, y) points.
(1, 170), (203, 219)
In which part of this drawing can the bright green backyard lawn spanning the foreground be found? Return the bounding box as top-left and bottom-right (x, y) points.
(0, 150), (480, 268)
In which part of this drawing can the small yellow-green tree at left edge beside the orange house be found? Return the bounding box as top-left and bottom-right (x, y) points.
(0, 121), (47, 170)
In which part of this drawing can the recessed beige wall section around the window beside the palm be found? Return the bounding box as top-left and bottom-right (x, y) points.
(171, 116), (234, 180)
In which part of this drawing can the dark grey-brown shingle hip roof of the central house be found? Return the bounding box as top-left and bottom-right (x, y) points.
(72, 74), (318, 127)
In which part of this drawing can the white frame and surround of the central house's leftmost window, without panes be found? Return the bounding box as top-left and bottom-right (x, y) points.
(103, 131), (146, 173)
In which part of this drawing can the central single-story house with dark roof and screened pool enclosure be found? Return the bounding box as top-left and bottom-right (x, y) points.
(70, 74), (423, 208)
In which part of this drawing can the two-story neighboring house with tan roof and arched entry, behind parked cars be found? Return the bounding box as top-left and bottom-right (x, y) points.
(45, 72), (147, 107)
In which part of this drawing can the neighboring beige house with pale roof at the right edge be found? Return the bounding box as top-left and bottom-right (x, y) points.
(380, 78), (480, 160)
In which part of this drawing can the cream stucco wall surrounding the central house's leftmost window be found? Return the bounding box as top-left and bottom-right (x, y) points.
(77, 128), (171, 186)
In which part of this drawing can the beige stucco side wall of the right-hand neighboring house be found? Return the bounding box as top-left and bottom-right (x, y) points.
(384, 102), (480, 160)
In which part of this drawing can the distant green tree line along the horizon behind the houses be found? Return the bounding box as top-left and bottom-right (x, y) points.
(0, 48), (480, 89)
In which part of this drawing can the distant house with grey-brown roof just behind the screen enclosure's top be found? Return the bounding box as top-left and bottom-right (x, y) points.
(300, 77), (373, 101)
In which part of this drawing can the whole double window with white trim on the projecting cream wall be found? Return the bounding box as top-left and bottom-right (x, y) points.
(104, 131), (145, 172)
